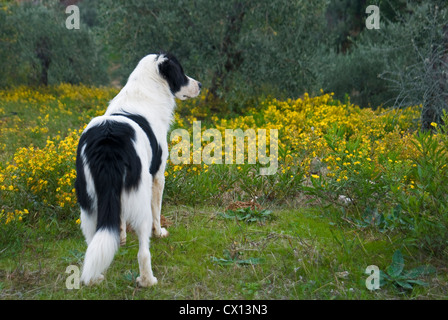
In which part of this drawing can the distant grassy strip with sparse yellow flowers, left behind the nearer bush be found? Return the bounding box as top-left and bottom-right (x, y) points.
(0, 84), (118, 156)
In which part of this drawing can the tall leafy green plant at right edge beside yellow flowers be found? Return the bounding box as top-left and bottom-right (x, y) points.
(396, 122), (448, 254)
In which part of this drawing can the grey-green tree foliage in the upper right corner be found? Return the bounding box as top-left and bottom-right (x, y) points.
(381, 2), (448, 130)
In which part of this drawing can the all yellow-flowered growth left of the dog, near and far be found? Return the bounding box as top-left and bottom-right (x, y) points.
(0, 84), (118, 224)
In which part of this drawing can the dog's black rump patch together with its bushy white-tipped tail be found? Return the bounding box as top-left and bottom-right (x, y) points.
(80, 121), (141, 285)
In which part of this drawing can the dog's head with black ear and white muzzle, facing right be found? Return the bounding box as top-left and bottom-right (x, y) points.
(155, 53), (202, 100)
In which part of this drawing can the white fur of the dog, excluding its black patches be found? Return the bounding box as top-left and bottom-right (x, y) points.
(81, 55), (200, 287)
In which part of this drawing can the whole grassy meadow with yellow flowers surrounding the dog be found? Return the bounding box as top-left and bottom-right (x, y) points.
(0, 84), (448, 299)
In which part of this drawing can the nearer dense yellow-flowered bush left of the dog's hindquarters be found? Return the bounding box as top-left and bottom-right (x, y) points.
(0, 130), (82, 223)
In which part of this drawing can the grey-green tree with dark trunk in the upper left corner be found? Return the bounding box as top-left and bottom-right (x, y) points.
(0, 1), (107, 86)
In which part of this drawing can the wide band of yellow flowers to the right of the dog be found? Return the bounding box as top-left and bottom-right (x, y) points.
(167, 92), (420, 205)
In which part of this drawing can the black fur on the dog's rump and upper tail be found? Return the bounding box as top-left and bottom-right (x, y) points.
(75, 120), (142, 230)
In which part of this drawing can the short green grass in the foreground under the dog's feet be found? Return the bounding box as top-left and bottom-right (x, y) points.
(0, 205), (447, 300)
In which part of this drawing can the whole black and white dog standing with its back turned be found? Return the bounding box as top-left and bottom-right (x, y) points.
(75, 53), (201, 287)
